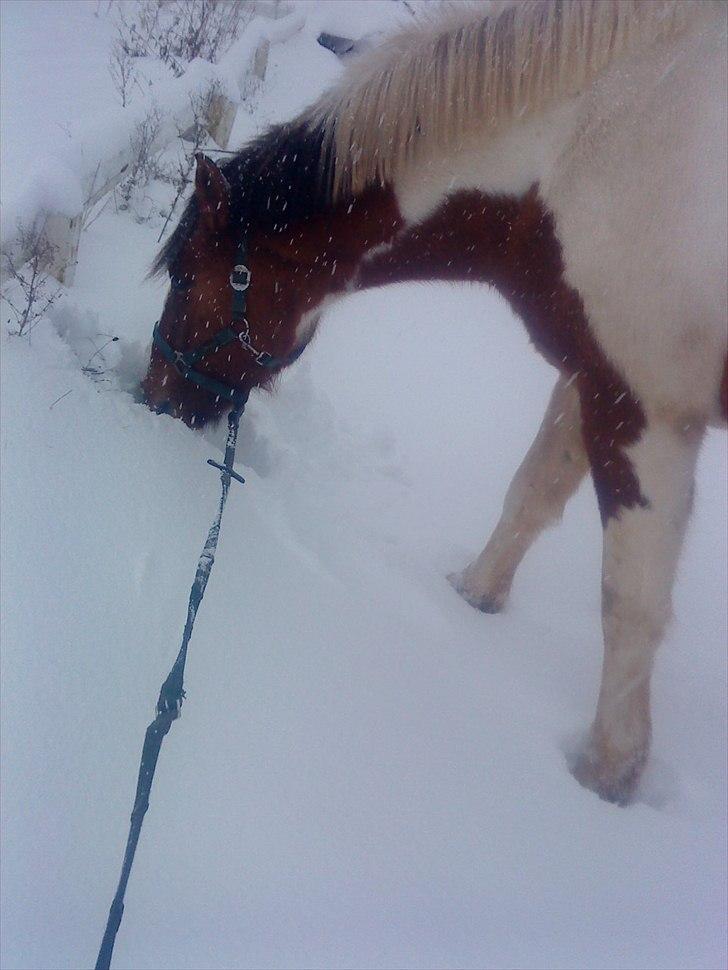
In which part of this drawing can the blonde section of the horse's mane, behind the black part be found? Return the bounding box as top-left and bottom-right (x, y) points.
(312, 0), (712, 196)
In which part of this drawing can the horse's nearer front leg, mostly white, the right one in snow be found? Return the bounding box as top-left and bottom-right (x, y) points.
(574, 412), (703, 804)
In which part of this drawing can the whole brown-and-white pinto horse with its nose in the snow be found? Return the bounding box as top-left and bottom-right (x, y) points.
(142, 0), (728, 805)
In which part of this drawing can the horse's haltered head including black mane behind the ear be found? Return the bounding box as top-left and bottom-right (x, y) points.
(142, 145), (401, 428)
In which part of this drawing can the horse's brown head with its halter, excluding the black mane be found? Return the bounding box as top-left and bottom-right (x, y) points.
(142, 155), (320, 428)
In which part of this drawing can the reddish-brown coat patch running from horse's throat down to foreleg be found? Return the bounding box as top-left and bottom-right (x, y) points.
(358, 187), (647, 522)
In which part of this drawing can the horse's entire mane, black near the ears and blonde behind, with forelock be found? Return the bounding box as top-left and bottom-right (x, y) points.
(150, 0), (712, 275)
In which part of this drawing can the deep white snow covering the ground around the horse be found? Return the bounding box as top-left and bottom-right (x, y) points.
(0, 0), (727, 970)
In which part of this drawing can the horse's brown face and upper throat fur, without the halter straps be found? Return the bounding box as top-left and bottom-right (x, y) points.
(142, 155), (401, 428)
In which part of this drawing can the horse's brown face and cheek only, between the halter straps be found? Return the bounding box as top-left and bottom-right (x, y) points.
(142, 155), (305, 428)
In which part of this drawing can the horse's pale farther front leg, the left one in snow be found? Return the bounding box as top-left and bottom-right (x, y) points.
(448, 378), (589, 613)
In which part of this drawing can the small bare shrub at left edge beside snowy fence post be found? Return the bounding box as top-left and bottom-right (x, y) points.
(2, 225), (61, 337)
